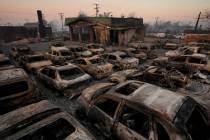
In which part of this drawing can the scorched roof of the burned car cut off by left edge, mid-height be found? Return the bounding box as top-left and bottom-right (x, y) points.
(0, 68), (28, 81)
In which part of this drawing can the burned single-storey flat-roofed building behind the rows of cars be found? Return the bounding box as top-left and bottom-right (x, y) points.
(65, 17), (144, 45)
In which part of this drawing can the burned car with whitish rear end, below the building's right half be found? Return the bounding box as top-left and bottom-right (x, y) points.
(102, 51), (139, 71)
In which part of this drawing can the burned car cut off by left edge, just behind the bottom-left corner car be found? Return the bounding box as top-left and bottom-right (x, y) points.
(0, 68), (38, 114)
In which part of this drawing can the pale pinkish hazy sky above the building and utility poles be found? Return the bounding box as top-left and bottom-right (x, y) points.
(0, 0), (210, 24)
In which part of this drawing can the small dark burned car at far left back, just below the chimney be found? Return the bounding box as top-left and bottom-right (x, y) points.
(9, 45), (34, 61)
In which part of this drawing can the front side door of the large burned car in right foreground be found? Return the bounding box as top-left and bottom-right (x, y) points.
(87, 97), (120, 137)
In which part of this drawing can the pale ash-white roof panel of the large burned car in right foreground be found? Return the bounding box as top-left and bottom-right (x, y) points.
(128, 83), (189, 121)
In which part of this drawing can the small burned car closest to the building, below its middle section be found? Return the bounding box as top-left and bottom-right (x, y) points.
(86, 43), (104, 55)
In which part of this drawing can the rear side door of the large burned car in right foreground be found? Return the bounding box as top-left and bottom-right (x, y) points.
(113, 104), (155, 140)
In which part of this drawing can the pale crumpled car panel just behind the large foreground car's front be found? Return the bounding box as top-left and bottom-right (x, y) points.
(108, 69), (138, 83)
